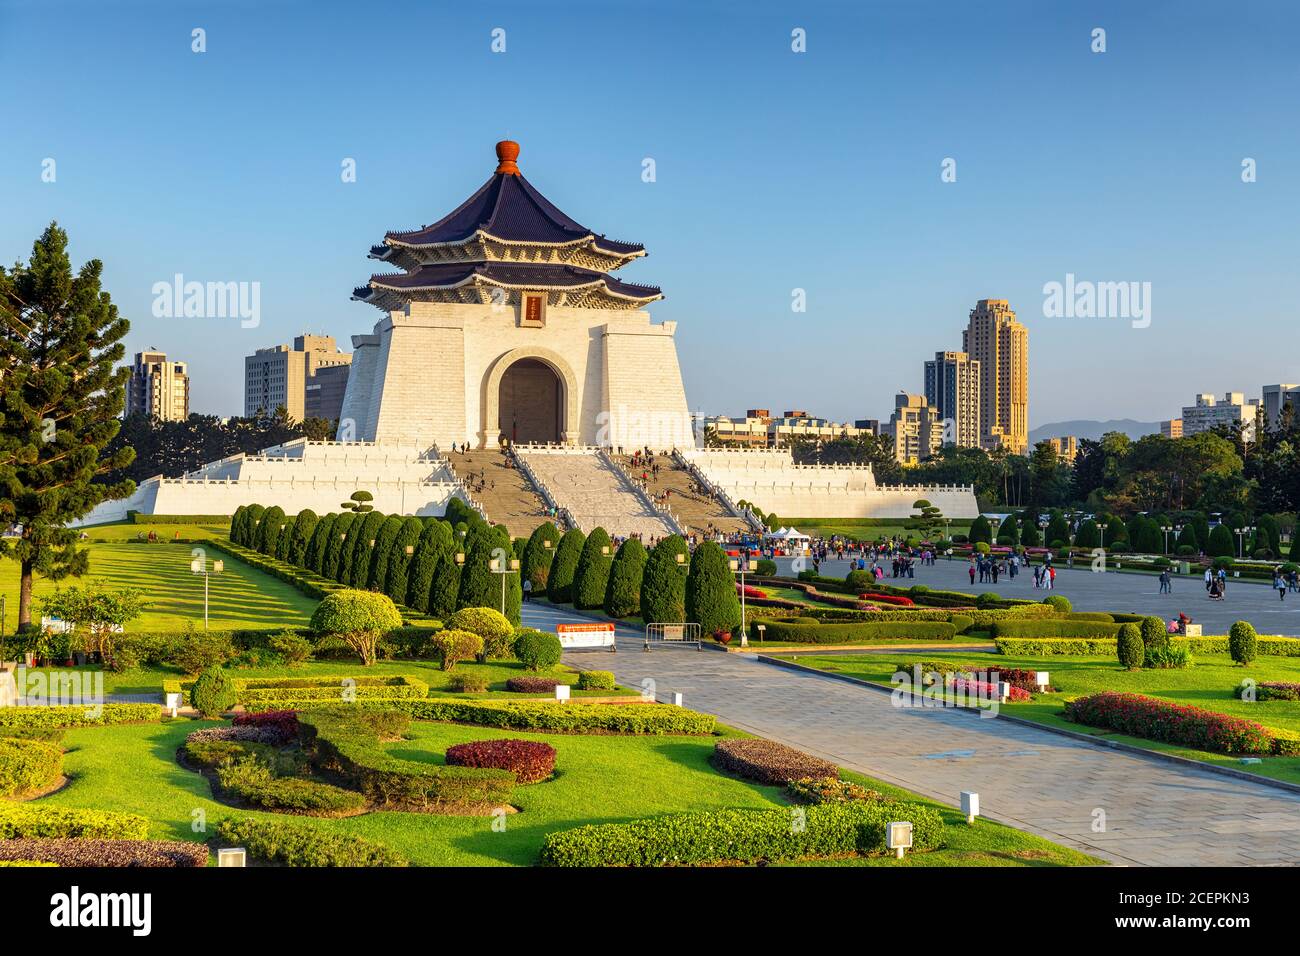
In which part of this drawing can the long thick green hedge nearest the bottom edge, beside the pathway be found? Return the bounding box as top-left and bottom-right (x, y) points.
(541, 800), (944, 866)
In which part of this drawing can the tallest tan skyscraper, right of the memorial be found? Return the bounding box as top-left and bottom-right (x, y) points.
(962, 299), (1030, 455)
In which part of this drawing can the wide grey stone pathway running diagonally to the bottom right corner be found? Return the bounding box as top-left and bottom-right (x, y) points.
(524, 605), (1300, 866)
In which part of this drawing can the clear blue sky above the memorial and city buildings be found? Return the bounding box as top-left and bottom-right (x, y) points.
(0, 0), (1300, 425)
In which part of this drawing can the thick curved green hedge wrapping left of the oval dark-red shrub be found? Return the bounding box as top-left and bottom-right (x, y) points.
(298, 709), (515, 808)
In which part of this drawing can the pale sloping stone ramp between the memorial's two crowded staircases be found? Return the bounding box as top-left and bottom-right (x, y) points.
(516, 447), (675, 542)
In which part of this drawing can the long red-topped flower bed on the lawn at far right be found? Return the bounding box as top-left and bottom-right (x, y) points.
(1065, 691), (1273, 753)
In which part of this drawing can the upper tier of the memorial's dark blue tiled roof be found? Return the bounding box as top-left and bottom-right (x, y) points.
(387, 173), (644, 255)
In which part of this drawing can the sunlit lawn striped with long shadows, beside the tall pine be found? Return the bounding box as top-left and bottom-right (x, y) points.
(0, 538), (316, 633)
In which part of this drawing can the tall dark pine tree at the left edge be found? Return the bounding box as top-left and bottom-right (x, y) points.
(0, 222), (135, 631)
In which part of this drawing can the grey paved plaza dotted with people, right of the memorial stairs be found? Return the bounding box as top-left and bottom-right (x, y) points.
(776, 558), (1300, 636)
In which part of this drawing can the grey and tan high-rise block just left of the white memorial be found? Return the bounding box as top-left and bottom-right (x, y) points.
(244, 336), (352, 421)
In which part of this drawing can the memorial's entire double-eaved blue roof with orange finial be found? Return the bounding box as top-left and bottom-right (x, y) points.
(352, 140), (663, 311)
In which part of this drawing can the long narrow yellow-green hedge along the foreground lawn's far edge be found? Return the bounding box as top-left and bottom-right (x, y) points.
(260, 697), (716, 736)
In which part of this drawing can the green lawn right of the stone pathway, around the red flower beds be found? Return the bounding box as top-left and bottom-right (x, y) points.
(784, 650), (1300, 783)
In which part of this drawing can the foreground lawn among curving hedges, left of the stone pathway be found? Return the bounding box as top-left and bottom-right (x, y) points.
(42, 719), (1097, 866)
